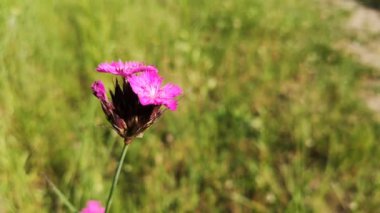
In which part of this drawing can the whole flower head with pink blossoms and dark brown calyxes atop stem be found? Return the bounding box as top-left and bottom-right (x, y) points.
(91, 62), (182, 143)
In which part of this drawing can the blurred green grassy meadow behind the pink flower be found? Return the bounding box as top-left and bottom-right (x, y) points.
(0, 0), (380, 212)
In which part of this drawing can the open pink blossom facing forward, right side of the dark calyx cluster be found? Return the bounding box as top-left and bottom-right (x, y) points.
(127, 72), (182, 110)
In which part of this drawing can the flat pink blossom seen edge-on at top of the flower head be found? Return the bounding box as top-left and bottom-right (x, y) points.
(96, 61), (158, 77)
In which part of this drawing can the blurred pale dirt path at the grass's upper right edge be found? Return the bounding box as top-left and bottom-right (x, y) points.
(335, 0), (380, 116)
